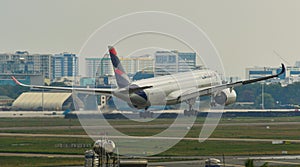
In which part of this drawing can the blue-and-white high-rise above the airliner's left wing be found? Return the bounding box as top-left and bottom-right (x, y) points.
(52, 53), (78, 79)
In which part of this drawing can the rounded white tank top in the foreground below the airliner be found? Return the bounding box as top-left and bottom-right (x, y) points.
(93, 139), (116, 155)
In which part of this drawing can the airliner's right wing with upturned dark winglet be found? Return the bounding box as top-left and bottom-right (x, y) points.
(167, 64), (285, 102)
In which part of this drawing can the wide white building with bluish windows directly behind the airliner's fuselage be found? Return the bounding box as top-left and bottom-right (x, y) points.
(154, 51), (196, 76)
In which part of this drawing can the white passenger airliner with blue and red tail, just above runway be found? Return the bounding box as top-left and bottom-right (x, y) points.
(12, 46), (285, 116)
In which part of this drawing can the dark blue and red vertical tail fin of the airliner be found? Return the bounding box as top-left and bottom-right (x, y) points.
(108, 46), (130, 88)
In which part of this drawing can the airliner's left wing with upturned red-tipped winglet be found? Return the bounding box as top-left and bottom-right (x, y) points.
(11, 76), (115, 95)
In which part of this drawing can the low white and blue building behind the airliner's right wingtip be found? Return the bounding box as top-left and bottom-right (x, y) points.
(246, 61), (300, 84)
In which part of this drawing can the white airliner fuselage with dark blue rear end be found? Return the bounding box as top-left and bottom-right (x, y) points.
(114, 70), (220, 109)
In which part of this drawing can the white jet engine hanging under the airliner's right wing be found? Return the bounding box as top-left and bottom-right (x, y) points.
(214, 88), (236, 106)
